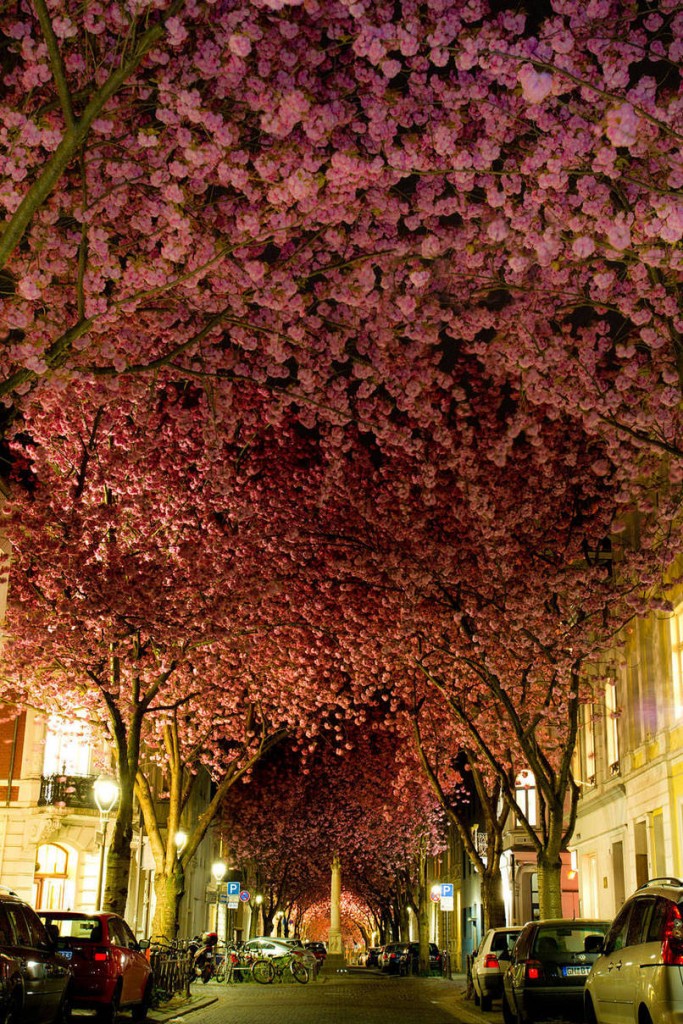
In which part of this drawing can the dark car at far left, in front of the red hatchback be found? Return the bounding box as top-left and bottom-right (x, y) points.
(0, 890), (72, 1024)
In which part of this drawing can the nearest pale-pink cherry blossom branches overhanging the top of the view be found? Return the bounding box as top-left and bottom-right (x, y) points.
(0, 0), (683, 489)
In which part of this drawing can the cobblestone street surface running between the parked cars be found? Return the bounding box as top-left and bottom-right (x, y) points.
(143, 972), (502, 1024)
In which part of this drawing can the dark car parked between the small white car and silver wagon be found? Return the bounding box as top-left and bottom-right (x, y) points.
(502, 918), (610, 1024)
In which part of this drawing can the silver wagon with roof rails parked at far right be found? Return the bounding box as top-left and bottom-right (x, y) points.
(584, 878), (683, 1024)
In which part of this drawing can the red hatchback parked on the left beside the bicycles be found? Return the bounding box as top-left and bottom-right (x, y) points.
(38, 910), (153, 1024)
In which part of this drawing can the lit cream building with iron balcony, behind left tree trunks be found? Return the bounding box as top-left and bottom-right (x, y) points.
(0, 708), (218, 938)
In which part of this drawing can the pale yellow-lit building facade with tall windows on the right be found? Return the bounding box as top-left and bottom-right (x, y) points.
(572, 602), (683, 918)
